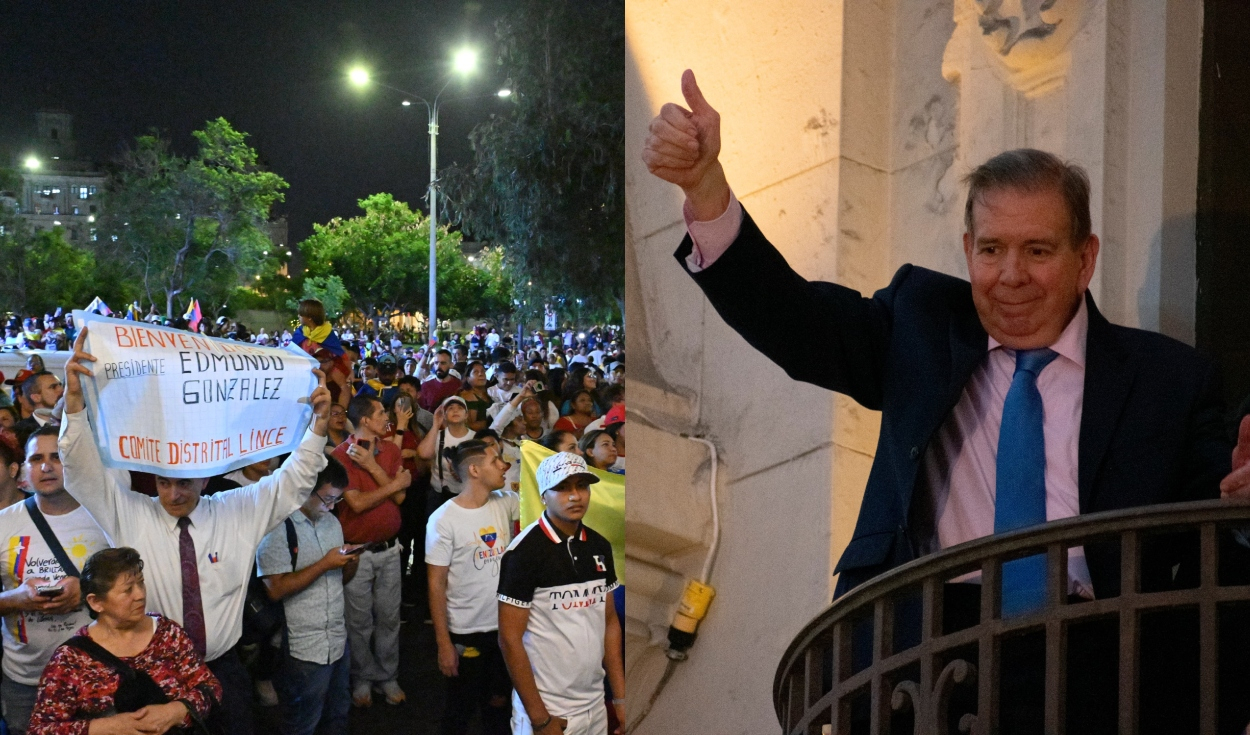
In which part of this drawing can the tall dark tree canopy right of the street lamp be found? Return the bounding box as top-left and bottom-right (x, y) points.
(443, 0), (625, 314)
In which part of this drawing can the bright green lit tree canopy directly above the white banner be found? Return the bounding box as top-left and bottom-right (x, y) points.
(96, 118), (288, 318)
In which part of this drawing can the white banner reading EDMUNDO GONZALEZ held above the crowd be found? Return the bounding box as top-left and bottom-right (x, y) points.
(74, 310), (318, 479)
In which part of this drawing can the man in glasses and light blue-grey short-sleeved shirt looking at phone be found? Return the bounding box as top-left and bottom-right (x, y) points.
(256, 458), (363, 735)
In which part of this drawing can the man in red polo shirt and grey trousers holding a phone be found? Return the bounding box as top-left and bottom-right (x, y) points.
(331, 395), (413, 708)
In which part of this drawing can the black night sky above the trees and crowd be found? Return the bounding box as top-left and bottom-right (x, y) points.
(0, 0), (508, 244)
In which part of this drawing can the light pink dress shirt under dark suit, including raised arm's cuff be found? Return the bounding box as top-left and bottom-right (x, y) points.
(683, 193), (1094, 599)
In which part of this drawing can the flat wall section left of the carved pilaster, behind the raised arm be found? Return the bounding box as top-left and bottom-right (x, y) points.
(625, 0), (850, 734)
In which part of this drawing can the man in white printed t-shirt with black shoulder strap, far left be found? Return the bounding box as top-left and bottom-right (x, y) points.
(0, 426), (110, 735)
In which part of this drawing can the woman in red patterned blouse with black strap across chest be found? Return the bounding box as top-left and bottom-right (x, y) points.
(28, 548), (221, 735)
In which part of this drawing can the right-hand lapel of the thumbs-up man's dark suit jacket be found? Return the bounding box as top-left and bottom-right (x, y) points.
(1076, 293), (1136, 514)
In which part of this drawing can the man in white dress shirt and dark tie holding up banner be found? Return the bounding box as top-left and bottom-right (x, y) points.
(60, 329), (331, 735)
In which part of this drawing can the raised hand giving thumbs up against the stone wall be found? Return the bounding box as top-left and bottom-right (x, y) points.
(643, 69), (729, 220)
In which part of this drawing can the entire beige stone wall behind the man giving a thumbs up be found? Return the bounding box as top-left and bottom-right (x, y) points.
(626, 0), (1201, 735)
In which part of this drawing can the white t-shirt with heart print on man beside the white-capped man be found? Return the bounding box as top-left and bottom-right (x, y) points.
(425, 490), (521, 634)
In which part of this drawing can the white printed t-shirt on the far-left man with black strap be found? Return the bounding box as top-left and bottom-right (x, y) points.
(0, 503), (110, 686)
